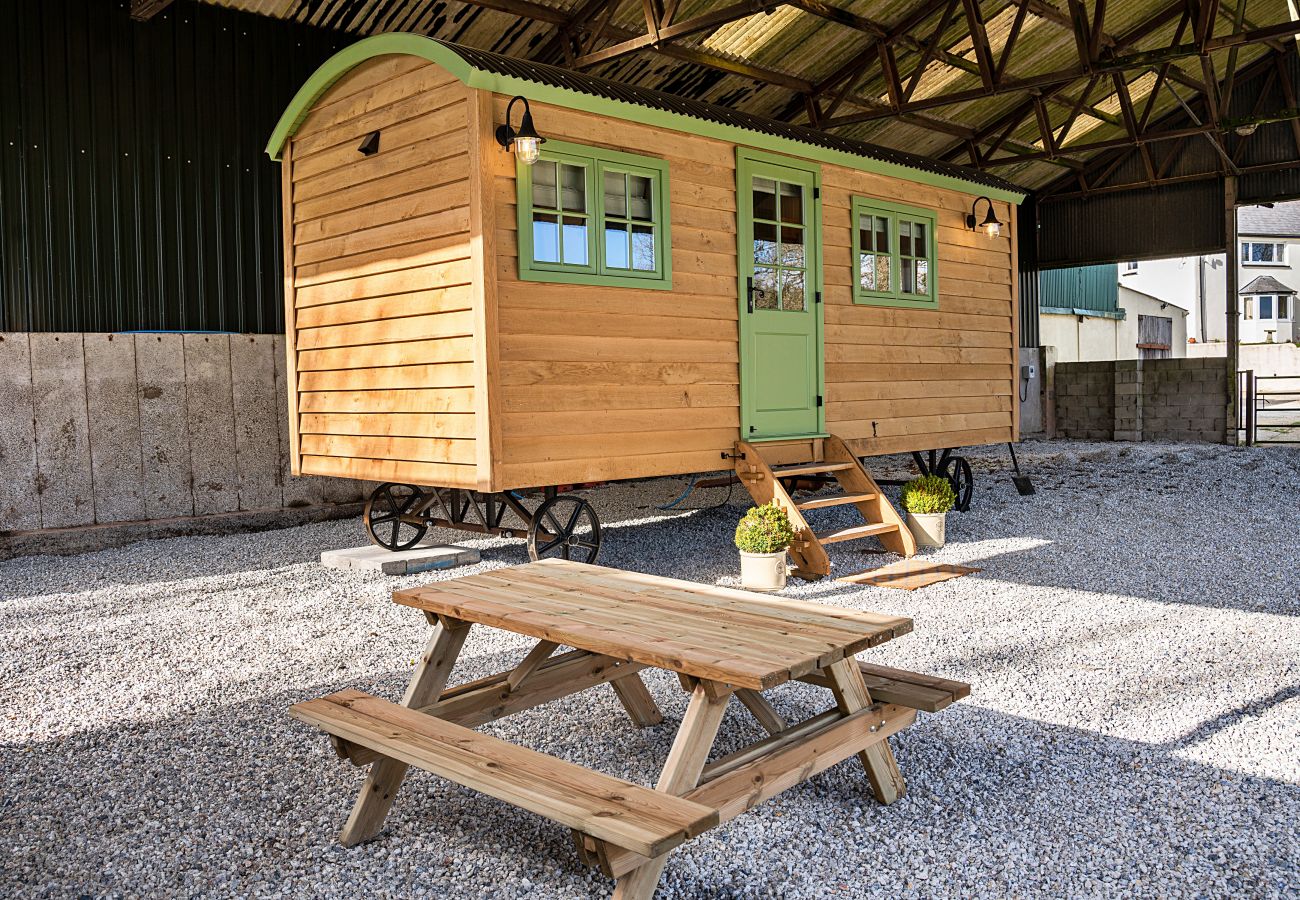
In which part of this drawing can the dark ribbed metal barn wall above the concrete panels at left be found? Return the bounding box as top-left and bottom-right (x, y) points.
(0, 0), (345, 333)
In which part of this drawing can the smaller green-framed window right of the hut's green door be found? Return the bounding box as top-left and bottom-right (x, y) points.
(850, 196), (939, 310)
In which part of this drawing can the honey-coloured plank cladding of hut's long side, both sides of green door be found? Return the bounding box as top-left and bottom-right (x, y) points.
(478, 95), (1017, 485)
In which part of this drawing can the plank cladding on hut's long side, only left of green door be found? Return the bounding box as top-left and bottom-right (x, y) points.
(493, 98), (740, 486)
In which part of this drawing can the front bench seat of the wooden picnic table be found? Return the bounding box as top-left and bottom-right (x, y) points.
(290, 691), (719, 857)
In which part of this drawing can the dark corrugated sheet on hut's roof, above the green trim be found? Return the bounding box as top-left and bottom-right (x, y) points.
(437, 40), (1024, 192)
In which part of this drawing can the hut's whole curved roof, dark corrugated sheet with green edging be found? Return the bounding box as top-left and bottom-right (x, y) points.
(267, 33), (1027, 203)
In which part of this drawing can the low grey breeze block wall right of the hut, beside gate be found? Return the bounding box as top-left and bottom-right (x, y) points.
(1056, 359), (1229, 443)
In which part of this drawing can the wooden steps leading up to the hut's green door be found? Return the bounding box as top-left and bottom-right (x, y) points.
(736, 434), (917, 579)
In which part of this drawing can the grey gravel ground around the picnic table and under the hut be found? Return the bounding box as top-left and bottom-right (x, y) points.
(0, 442), (1300, 899)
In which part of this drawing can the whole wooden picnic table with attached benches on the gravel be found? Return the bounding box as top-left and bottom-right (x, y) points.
(290, 559), (970, 900)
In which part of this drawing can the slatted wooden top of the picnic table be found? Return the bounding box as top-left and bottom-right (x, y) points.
(393, 559), (911, 691)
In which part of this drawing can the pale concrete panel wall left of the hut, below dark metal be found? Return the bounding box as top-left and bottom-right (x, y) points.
(0, 333), (365, 535)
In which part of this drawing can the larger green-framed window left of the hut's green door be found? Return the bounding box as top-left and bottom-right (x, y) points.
(515, 140), (672, 290)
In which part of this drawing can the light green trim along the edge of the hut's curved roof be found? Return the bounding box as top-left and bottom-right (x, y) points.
(267, 33), (1028, 204)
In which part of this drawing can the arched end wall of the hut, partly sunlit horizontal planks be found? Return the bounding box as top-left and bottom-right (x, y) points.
(286, 57), (477, 486)
